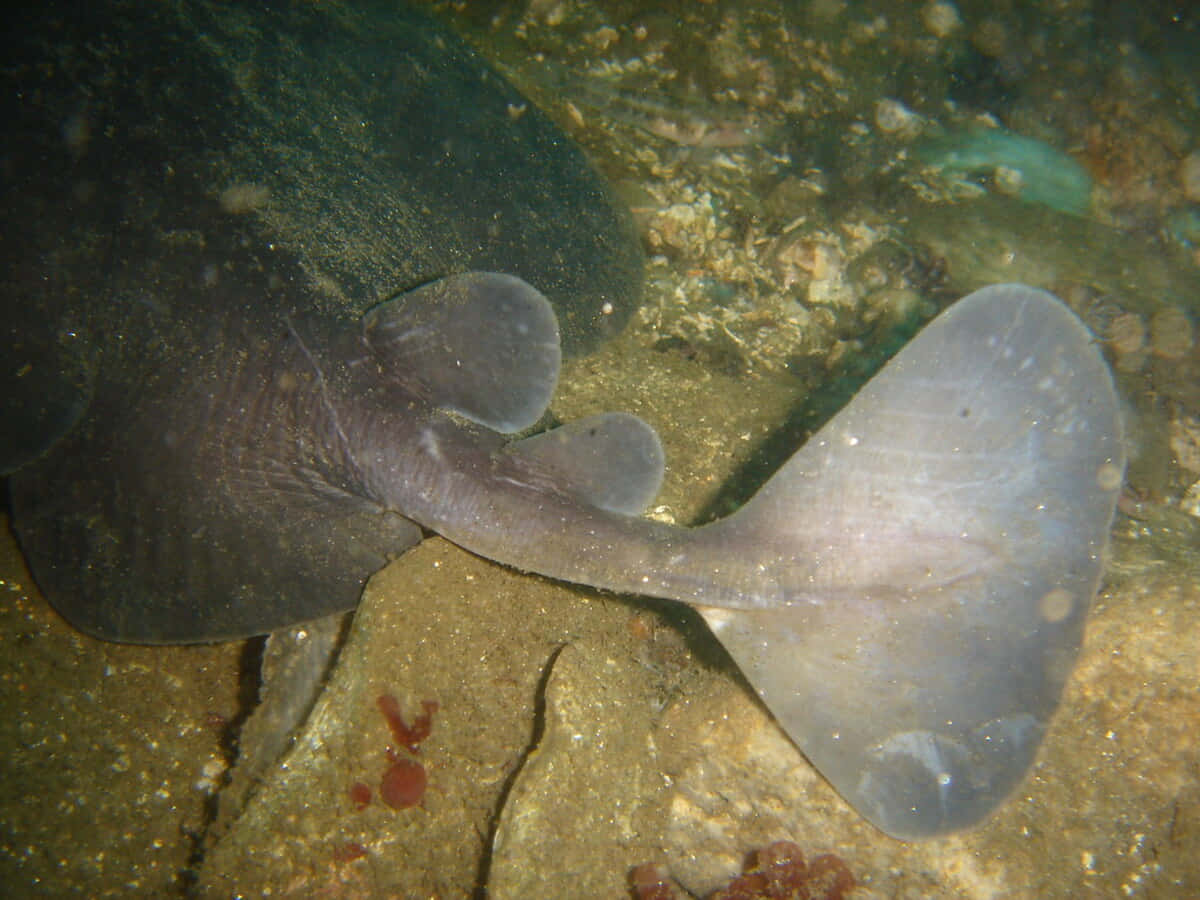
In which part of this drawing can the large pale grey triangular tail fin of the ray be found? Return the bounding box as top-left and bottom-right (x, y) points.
(701, 284), (1124, 839)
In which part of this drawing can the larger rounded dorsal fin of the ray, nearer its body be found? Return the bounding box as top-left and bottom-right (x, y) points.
(362, 272), (562, 433)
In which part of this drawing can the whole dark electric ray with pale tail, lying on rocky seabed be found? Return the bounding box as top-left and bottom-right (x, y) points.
(5, 6), (1124, 838)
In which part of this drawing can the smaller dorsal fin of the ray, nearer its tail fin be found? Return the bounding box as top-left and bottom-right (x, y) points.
(504, 413), (664, 516)
